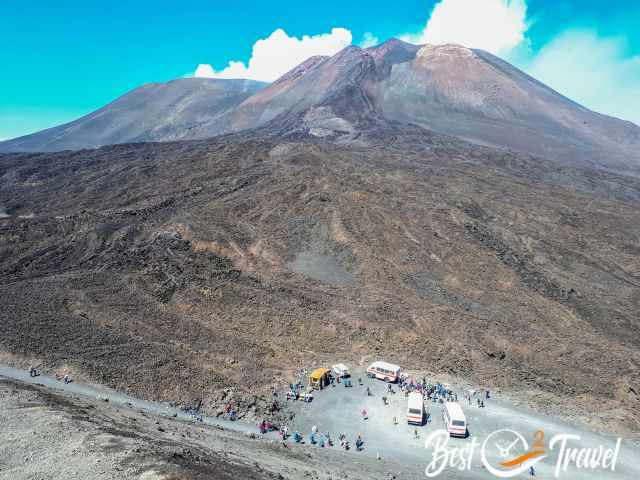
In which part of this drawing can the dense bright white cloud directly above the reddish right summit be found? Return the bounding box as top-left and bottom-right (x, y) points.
(405, 0), (527, 54)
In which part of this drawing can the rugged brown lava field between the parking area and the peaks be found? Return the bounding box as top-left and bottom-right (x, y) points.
(0, 127), (640, 432)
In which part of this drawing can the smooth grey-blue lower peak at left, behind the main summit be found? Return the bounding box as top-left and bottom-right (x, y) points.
(0, 78), (265, 151)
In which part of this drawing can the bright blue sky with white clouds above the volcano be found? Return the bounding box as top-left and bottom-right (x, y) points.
(0, 0), (640, 139)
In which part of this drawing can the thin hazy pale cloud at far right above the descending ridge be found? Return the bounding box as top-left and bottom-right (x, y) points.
(521, 30), (640, 125)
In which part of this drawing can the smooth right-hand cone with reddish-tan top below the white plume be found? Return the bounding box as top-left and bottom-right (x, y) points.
(376, 45), (640, 169)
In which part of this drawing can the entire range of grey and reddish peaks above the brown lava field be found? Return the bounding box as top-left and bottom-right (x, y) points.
(0, 39), (640, 170)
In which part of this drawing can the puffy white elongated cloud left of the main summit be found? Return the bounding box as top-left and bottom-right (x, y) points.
(194, 28), (352, 82)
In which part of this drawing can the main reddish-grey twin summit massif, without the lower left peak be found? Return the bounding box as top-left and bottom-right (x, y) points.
(196, 40), (640, 170)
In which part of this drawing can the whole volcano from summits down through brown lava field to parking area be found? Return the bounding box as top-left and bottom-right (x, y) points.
(0, 41), (640, 434)
